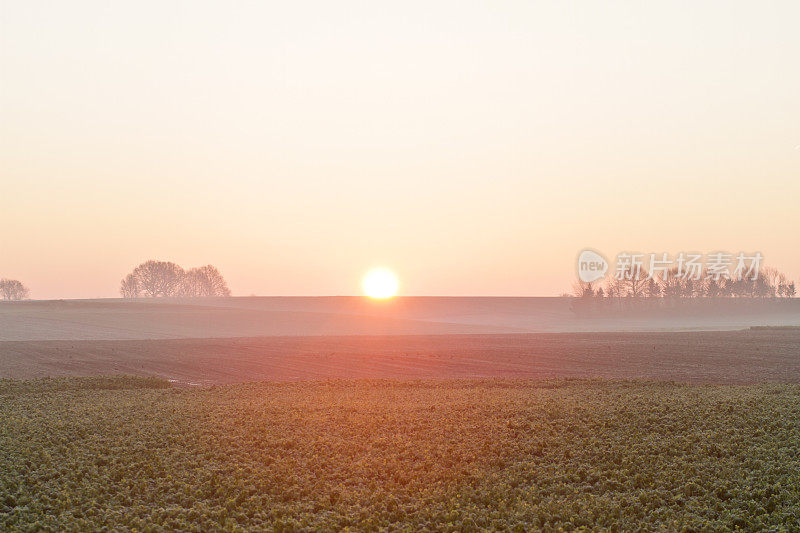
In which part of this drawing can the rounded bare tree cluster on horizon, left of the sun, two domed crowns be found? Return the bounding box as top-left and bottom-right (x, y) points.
(119, 260), (231, 298)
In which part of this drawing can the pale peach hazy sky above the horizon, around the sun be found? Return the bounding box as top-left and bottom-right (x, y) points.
(0, 0), (800, 298)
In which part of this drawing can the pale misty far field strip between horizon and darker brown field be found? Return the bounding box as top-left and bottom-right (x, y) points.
(0, 297), (800, 341)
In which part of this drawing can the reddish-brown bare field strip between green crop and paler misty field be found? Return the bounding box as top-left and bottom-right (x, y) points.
(0, 328), (800, 384)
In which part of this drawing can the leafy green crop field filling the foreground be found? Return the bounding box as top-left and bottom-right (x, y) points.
(0, 378), (800, 531)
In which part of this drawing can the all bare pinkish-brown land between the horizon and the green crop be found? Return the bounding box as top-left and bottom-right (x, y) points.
(0, 297), (800, 385)
